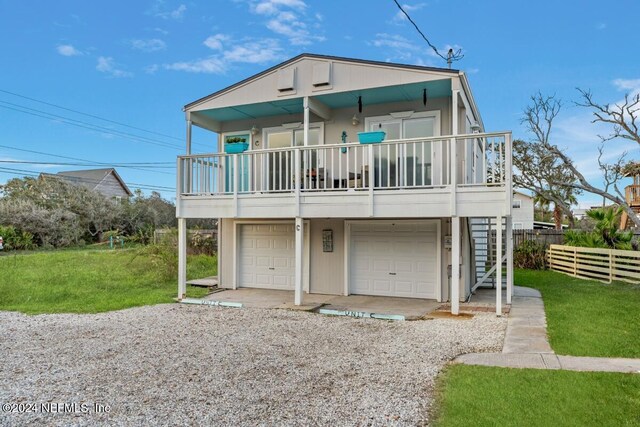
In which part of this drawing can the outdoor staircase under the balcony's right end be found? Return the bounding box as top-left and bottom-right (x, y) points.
(468, 218), (507, 291)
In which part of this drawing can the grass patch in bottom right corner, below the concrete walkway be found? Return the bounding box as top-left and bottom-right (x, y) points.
(434, 365), (640, 427)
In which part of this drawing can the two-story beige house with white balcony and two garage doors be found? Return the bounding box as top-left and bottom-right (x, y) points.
(176, 54), (513, 313)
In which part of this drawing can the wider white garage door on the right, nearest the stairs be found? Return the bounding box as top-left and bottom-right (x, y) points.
(349, 222), (438, 299)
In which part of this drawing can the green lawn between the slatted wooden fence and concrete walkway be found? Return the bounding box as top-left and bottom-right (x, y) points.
(515, 270), (640, 358)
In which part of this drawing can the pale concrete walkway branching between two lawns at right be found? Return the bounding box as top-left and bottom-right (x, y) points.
(454, 286), (640, 373)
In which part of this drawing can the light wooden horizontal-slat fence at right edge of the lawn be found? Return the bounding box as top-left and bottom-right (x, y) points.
(547, 245), (640, 283)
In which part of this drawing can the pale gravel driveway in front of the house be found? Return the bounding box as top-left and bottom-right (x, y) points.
(0, 304), (506, 426)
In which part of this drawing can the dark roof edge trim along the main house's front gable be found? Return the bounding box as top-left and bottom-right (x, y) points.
(183, 53), (460, 111)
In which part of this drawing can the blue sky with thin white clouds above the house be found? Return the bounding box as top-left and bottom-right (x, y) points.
(0, 0), (640, 204)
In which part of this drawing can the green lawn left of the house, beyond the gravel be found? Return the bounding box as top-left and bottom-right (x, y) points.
(0, 248), (217, 314)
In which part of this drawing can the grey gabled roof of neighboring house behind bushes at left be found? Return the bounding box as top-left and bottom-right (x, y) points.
(40, 168), (133, 201)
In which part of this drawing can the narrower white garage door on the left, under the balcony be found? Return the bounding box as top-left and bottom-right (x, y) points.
(238, 224), (296, 290)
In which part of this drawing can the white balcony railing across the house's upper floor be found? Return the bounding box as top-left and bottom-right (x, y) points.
(178, 133), (511, 196)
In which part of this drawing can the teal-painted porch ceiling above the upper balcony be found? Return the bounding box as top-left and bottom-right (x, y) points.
(193, 79), (451, 122)
